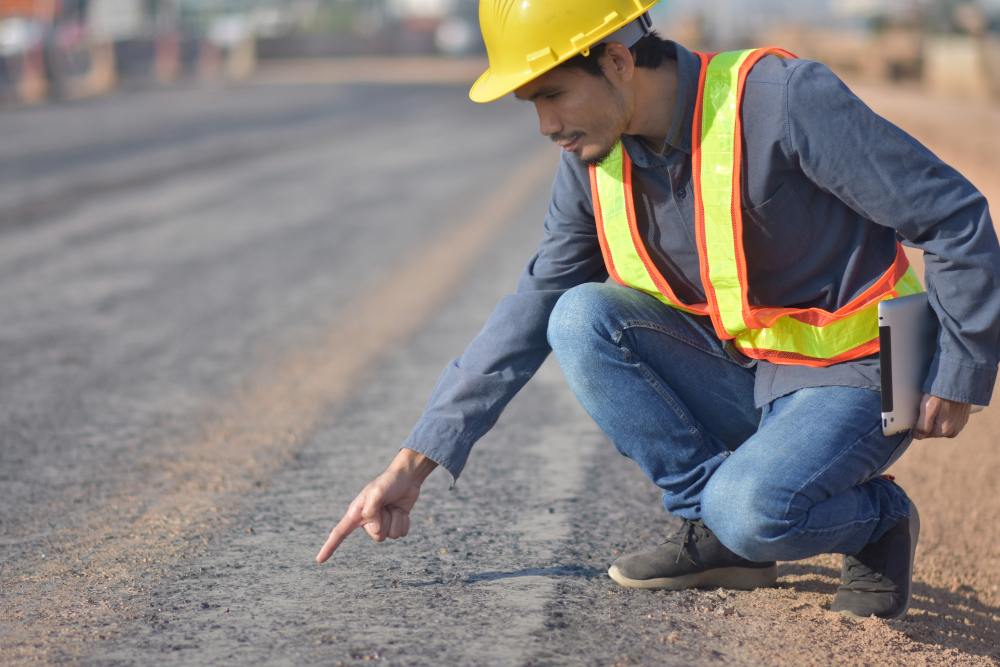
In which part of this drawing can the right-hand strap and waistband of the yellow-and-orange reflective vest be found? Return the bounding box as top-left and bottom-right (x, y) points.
(692, 48), (922, 366)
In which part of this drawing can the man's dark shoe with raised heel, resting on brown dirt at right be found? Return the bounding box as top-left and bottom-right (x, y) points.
(830, 500), (920, 619)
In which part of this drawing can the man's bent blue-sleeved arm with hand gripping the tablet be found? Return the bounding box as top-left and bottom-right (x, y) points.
(786, 57), (1000, 438)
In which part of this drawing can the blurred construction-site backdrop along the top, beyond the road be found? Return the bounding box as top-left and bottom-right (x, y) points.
(0, 0), (1000, 104)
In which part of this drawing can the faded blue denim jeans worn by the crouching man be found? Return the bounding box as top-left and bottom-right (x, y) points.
(548, 283), (910, 561)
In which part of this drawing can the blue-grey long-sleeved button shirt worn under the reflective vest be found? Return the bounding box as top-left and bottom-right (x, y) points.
(403, 40), (1000, 479)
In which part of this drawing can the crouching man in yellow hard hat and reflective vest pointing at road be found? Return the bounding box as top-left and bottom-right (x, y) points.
(318, 0), (1000, 618)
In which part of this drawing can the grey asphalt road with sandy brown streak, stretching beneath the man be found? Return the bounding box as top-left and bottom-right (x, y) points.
(0, 70), (997, 665)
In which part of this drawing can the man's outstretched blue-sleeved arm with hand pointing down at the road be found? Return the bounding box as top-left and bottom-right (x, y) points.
(316, 151), (607, 563)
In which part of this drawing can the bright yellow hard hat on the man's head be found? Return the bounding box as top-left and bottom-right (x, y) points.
(469, 0), (659, 102)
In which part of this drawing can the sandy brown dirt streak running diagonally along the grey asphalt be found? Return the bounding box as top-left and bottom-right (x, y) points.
(0, 147), (555, 662)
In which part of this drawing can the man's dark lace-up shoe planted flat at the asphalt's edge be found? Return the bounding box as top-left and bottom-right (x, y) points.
(608, 520), (778, 591)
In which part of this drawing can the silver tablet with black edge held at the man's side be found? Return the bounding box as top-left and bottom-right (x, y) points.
(878, 292), (982, 435)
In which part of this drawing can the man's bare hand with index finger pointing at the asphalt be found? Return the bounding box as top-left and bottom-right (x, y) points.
(316, 448), (437, 563)
